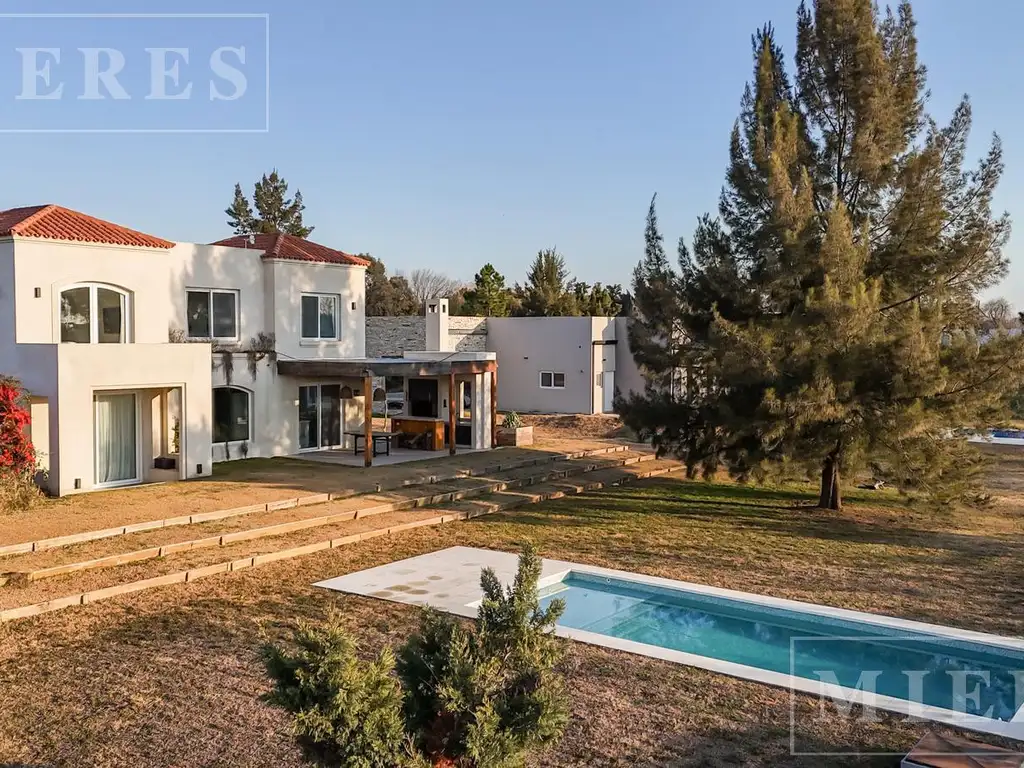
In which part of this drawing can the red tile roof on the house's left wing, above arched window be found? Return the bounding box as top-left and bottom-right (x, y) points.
(0, 205), (174, 248)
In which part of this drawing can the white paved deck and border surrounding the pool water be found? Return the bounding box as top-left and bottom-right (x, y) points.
(314, 547), (1024, 740)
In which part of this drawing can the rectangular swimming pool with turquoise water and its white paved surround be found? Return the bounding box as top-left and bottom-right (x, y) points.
(317, 547), (1024, 740)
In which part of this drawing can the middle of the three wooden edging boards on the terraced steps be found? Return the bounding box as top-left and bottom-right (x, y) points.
(0, 454), (654, 587)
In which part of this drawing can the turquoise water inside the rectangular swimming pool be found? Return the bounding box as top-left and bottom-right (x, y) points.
(542, 571), (1024, 721)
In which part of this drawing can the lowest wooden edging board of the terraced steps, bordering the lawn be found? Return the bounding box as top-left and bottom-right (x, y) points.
(0, 466), (686, 624)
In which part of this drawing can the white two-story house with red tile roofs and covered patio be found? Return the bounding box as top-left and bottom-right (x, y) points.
(0, 205), (497, 496)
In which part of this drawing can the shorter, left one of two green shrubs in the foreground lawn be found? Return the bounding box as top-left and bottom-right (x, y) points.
(263, 616), (408, 768)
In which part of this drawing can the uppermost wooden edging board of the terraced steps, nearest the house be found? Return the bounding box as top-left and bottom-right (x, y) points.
(0, 445), (633, 557)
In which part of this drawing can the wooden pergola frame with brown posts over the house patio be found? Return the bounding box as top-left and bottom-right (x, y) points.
(278, 357), (498, 467)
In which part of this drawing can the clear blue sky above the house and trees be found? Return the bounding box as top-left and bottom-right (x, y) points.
(0, 0), (1024, 306)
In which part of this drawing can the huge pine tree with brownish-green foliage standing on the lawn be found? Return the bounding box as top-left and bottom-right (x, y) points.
(621, 0), (1024, 518)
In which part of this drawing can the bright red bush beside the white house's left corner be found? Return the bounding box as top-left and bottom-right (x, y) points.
(0, 377), (38, 509)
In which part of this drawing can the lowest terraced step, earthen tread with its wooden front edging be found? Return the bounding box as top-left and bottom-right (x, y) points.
(0, 461), (684, 623)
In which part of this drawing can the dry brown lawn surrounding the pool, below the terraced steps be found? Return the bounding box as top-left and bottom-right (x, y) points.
(0, 452), (1024, 768)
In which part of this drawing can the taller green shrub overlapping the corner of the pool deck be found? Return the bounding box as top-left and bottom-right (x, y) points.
(397, 547), (568, 768)
